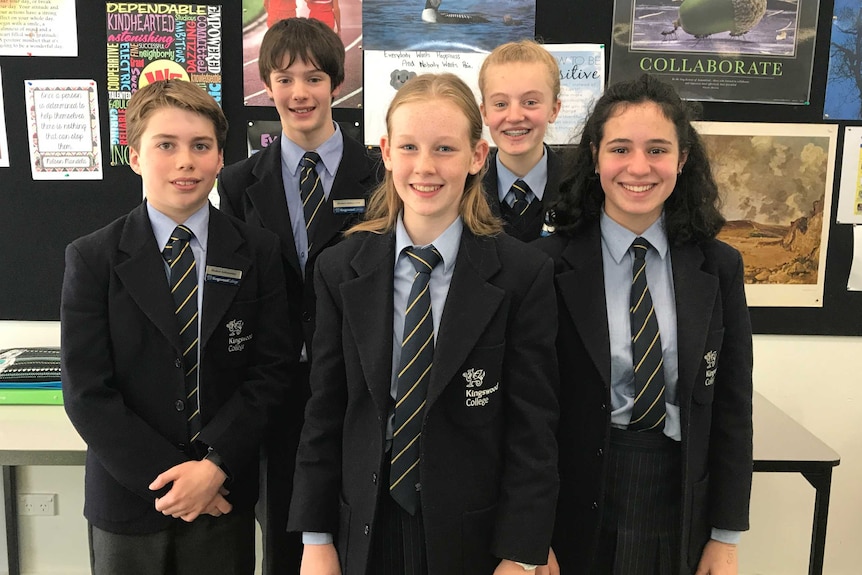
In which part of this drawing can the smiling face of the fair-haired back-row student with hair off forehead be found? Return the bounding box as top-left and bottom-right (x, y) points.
(481, 62), (561, 176)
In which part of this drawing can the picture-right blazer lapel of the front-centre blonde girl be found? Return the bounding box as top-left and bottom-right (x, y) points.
(427, 233), (505, 407)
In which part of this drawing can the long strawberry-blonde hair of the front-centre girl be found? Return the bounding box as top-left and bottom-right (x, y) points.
(345, 74), (503, 236)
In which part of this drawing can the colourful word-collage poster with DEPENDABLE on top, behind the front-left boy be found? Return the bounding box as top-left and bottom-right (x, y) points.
(106, 0), (222, 166)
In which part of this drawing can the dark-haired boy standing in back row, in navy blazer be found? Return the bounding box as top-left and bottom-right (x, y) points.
(218, 18), (379, 575)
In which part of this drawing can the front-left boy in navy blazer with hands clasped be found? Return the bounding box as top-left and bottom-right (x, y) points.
(60, 80), (296, 575)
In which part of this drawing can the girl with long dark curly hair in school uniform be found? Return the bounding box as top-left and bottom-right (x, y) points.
(534, 75), (752, 575)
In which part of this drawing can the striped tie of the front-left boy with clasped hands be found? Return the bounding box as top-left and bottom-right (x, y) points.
(162, 225), (201, 441)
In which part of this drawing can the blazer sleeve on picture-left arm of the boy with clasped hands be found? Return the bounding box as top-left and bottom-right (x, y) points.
(60, 244), (187, 499)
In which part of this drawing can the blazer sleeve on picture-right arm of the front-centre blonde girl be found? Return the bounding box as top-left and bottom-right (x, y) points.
(492, 256), (559, 564)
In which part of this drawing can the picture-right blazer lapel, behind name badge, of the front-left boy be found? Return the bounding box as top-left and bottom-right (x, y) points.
(200, 206), (251, 349)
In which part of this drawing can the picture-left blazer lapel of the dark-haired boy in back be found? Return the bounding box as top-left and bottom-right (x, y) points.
(246, 142), (302, 278)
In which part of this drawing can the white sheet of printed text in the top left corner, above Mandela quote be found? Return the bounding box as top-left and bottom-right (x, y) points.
(0, 0), (78, 57)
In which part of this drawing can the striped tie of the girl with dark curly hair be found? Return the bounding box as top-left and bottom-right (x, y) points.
(628, 237), (665, 431)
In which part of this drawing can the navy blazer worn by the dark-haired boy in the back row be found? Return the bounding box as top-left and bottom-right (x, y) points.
(218, 133), (381, 360)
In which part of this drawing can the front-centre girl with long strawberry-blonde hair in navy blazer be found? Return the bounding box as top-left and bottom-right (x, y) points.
(288, 74), (557, 575)
